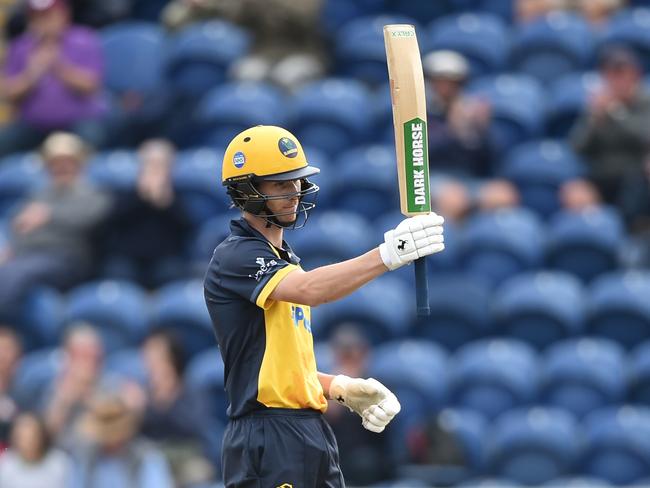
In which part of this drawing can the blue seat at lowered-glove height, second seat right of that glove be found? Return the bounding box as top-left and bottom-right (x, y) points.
(451, 339), (538, 419)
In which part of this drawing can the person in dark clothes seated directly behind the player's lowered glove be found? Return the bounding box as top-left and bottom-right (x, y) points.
(326, 323), (395, 486)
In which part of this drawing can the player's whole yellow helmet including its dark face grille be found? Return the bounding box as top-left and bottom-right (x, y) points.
(221, 125), (320, 228)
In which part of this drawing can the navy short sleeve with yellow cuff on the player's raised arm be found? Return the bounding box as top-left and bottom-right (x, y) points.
(209, 239), (298, 309)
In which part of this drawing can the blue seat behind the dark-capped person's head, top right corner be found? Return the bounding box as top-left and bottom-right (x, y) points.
(599, 7), (650, 71)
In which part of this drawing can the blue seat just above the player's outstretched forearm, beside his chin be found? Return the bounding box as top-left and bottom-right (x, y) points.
(285, 210), (378, 271)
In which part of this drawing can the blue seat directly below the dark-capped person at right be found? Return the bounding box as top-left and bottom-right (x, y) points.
(545, 207), (625, 282)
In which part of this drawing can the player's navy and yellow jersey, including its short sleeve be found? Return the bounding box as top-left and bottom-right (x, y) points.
(204, 218), (327, 418)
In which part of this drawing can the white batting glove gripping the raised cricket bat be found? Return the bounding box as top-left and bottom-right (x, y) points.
(379, 212), (445, 271)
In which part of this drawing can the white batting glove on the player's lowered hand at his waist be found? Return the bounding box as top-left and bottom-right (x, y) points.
(329, 374), (402, 433)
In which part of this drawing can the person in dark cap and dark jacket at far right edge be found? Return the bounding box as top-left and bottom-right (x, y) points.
(571, 46), (650, 204)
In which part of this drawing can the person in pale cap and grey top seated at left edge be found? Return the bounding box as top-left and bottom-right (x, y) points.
(0, 132), (109, 310)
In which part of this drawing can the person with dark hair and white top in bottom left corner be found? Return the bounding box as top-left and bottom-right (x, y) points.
(0, 413), (72, 488)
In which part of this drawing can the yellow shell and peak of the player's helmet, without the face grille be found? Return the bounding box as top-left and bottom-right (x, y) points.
(221, 125), (320, 185)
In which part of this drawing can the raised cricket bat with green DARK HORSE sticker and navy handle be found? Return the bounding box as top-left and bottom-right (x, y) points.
(384, 24), (431, 317)
